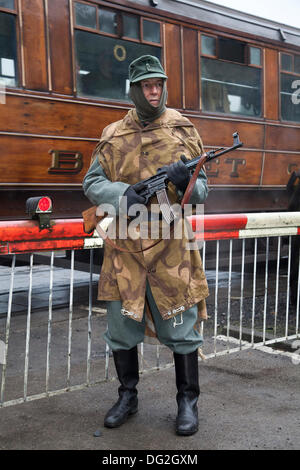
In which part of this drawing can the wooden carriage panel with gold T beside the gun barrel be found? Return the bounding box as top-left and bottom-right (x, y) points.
(205, 151), (262, 186)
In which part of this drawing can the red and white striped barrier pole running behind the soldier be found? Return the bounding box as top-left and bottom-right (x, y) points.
(0, 212), (300, 254)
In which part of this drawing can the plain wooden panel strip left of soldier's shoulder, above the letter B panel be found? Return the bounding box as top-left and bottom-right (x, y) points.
(0, 95), (126, 138)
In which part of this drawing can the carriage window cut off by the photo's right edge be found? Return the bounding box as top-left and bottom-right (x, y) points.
(280, 54), (300, 122)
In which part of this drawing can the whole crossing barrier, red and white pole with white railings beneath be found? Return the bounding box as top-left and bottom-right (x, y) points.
(0, 213), (300, 407)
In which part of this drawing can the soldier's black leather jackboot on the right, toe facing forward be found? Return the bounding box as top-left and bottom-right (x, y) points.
(174, 349), (200, 436)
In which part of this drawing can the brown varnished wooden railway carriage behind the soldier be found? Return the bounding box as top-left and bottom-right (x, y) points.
(0, 0), (300, 220)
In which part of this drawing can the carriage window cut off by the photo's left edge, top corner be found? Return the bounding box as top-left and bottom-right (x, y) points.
(0, 11), (17, 86)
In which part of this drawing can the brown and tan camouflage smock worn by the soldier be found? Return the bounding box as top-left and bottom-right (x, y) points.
(83, 109), (209, 321)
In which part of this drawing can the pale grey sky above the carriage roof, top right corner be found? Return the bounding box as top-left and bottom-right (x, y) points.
(207, 0), (300, 28)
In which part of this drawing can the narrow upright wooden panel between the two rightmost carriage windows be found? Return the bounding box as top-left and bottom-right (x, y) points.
(264, 48), (279, 120)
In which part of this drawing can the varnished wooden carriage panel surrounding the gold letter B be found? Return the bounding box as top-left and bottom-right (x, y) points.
(0, 136), (96, 185)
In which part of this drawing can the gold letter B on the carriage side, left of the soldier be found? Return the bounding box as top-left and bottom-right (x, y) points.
(48, 149), (83, 175)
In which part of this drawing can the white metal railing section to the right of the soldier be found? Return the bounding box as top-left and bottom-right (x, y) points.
(204, 236), (300, 358)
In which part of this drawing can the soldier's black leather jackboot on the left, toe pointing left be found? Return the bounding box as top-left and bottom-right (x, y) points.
(104, 346), (139, 428)
